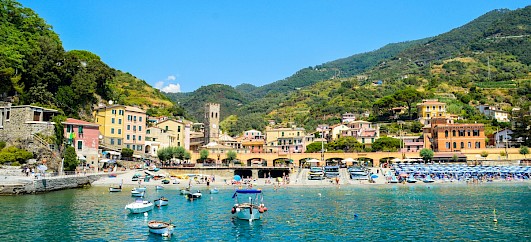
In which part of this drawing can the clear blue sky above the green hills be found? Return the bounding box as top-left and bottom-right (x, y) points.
(20, 0), (531, 92)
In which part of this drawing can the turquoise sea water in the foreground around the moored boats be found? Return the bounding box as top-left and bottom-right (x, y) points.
(0, 183), (531, 241)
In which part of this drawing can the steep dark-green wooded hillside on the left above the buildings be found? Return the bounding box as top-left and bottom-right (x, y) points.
(0, 0), (180, 120)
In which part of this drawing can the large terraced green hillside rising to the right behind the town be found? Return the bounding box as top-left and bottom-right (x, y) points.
(169, 7), (531, 134)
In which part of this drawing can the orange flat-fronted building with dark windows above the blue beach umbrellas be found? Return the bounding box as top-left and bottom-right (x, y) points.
(425, 118), (485, 152)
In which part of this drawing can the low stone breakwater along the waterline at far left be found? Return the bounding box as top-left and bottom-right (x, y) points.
(0, 174), (108, 195)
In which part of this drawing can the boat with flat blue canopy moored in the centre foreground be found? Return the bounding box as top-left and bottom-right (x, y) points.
(231, 189), (267, 221)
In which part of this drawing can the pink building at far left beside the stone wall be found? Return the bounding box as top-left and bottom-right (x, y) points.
(63, 118), (100, 168)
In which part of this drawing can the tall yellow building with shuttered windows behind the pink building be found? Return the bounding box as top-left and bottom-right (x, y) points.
(93, 105), (146, 155)
